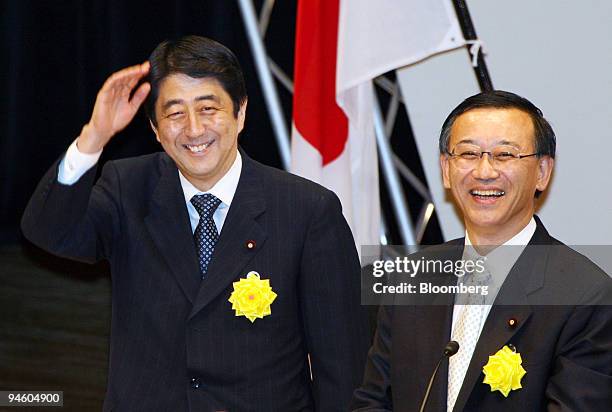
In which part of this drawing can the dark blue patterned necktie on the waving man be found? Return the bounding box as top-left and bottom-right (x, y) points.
(191, 193), (221, 278)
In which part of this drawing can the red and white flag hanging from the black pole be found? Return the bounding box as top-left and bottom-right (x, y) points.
(291, 0), (464, 263)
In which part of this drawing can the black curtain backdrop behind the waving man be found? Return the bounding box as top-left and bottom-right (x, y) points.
(0, 0), (296, 243)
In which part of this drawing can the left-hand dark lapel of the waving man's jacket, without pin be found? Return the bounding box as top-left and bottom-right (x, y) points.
(145, 155), (200, 302)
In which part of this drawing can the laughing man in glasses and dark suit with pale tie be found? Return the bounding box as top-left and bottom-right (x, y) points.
(352, 91), (612, 412)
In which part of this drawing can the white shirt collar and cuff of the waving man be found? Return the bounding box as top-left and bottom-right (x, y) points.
(57, 139), (242, 233)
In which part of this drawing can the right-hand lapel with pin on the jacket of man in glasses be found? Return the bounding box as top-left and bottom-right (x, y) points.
(454, 216), (551, 411)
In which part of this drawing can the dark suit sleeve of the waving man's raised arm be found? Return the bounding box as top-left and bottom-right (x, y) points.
(21, 156), (120, 263)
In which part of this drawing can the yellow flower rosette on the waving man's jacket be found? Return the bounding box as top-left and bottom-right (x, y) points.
(229, 272), (277, 323)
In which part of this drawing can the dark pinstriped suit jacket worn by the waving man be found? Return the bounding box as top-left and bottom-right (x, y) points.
(22, 153), (369, 411)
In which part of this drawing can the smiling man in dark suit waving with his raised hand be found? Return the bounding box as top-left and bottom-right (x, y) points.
(22, 36), (368, 411)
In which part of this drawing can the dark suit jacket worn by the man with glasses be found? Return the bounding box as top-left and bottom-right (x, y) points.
(352, 217), (612, 412)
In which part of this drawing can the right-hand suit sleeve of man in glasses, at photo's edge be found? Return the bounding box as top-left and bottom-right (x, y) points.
(546, 279), (612, 412)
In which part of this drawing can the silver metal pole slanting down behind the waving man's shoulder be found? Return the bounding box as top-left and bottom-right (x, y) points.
(238, 0), (291, 170)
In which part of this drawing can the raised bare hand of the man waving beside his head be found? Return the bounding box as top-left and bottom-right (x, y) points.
(77, 62), (151, 153)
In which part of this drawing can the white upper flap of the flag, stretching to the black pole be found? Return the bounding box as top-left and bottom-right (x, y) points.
(336, 0), (465, 94)
